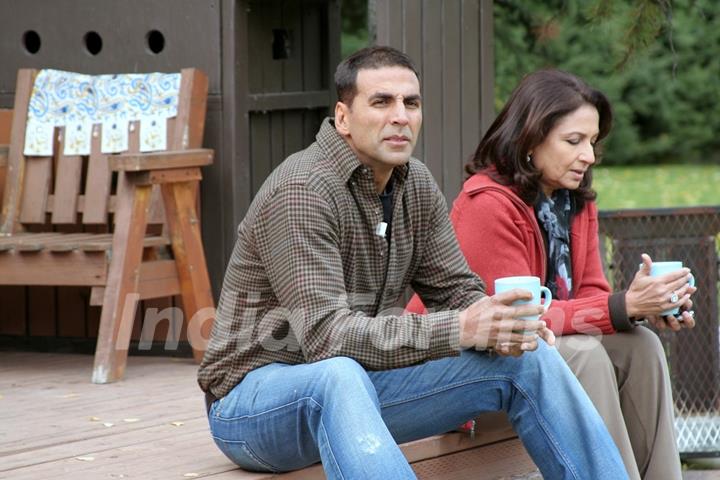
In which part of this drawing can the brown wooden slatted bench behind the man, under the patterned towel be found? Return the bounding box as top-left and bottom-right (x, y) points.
(0, 69), (214, 383)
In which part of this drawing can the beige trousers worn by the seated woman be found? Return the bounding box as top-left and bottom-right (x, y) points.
(556, 327), (682, 480)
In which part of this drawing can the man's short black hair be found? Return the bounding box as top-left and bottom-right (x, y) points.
(335, 46), (420, 106)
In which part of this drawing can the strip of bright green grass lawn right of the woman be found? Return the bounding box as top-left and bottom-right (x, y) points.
(593, 165), (720, 210)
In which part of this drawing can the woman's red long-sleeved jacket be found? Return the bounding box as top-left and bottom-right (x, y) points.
(408, 173), (615, 335)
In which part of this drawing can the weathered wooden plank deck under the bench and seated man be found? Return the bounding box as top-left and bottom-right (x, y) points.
(0, 351), (720, 480)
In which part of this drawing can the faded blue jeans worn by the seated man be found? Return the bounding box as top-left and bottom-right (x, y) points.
(209, 342), (627, 480)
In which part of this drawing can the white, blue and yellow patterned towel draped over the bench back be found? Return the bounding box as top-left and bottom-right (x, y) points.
(24, 70), (180, 156)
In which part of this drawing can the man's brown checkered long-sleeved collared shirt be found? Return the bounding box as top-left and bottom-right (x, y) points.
(198, 119), (485, 398)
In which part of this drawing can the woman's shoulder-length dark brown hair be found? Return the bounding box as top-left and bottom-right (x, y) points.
(465, 69), (612, 209)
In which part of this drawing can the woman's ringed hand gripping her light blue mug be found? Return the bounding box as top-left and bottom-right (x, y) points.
(625, 253), (697, 318)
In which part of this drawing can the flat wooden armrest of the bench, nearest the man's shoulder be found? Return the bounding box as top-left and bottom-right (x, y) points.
(110, 148), (214, 172)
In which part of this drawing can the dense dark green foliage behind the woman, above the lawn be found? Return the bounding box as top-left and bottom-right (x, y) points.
(494, 0), (720, 165)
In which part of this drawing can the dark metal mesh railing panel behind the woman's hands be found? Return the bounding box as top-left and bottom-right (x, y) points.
(600, 207), (720, 457)
